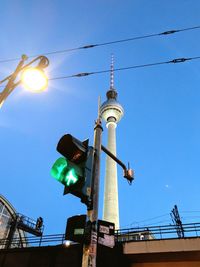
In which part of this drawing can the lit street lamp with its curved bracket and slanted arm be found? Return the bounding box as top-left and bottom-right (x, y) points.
(0, 55), (49, 107)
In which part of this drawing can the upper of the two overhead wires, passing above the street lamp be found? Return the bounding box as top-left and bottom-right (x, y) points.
(0, 26), (200, 63)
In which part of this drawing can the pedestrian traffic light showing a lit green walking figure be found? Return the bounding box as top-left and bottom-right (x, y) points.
(51, 134), (94, 207)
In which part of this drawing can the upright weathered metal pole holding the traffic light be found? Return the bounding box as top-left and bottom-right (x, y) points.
(82, 116), (103, 267)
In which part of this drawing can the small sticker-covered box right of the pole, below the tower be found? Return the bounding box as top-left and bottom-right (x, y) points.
(98, 220), (115, 248)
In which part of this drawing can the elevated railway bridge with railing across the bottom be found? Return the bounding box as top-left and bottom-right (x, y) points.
(0, 223), (200, 267)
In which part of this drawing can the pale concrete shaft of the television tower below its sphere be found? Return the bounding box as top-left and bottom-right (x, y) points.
(103, 118), (119, 229)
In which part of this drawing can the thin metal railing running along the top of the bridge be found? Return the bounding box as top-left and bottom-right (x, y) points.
(0, 223), (200, 249)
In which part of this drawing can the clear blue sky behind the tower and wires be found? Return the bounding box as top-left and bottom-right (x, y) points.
(0, 0), (200, 234)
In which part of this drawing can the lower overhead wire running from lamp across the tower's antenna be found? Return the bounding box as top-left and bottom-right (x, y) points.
(49, 56), (200, 80)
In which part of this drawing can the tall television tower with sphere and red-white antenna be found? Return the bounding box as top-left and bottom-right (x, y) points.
(100, 56), (124, 229)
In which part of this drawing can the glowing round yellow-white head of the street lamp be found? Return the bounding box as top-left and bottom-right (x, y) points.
(21, 68), (48, 92)
